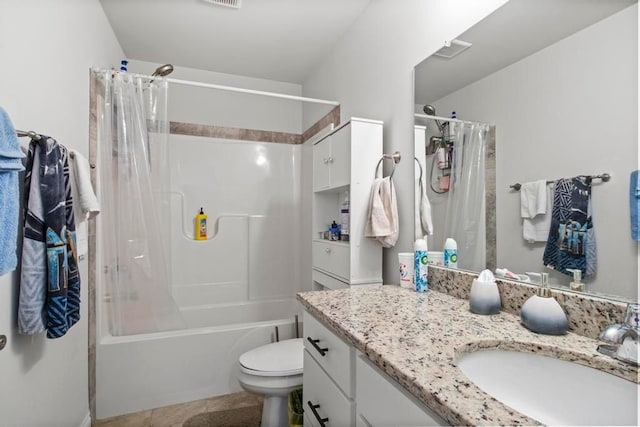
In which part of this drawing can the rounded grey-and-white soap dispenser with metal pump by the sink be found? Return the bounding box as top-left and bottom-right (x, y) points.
(520, 273), (569, 335)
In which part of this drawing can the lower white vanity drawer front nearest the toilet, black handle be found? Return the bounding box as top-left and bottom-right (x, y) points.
(302, 350), (355, 426)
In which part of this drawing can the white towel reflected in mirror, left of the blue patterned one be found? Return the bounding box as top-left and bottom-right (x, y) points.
(520, 179), (552, 243)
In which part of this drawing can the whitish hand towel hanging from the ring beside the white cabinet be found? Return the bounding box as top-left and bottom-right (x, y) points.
(365, 177), (399, 248)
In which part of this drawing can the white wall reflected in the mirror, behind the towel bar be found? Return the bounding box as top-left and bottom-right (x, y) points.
(436, 4), (638, 298)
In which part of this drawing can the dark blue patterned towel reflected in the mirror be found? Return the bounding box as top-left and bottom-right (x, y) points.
(543, 176), (597, 277)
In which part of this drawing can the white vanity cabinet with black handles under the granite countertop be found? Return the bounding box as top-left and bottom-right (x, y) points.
(302, 311), (447, 427)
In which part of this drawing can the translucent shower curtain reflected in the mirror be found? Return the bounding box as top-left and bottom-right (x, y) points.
(444, 122), (490, 271)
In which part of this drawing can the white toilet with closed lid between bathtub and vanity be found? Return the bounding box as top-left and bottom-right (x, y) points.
(238, 338), (304, 427)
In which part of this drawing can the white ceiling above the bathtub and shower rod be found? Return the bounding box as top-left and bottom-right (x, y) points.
(100, 0), (370, 84)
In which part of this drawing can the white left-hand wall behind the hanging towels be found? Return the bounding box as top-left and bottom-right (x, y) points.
(0, 0), (123, 427)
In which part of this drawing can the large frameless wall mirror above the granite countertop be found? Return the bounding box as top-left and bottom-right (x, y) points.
(414, 0), (638, 300)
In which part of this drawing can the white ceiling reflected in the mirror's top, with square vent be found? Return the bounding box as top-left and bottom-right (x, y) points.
(415, 0), (637, 105)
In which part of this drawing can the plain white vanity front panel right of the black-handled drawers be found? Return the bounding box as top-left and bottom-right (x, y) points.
(356, 352), (448, 426)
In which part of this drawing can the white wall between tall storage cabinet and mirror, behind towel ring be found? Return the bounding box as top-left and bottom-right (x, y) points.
(303, 0), (505, 283)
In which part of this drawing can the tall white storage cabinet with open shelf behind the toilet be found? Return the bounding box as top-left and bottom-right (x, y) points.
(311, 118), (383, 289)
